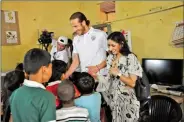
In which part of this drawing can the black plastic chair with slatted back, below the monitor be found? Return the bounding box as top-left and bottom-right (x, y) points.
(149, 95), (182, 122)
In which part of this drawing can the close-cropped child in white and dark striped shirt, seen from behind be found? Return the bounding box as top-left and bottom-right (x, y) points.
(56, 80), (90, 122)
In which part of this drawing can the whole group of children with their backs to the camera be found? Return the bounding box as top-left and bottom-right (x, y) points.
(2, 48), (101, 122)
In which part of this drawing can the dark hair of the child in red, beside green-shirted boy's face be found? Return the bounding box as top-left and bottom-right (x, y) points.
(49, 60), (67, 82)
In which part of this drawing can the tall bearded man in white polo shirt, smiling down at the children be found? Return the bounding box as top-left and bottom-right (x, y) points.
(64, 12), (108, 78)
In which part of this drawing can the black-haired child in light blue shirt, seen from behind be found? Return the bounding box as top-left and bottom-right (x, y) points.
(75, 72), (101, 122)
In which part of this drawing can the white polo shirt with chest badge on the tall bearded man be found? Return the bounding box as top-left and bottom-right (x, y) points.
(73, 27), (108, 75)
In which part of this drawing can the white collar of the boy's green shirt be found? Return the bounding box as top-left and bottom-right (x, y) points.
(23, 79), (45, 89)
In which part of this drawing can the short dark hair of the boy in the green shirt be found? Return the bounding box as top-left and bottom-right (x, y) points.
(23, 48), (51, 75)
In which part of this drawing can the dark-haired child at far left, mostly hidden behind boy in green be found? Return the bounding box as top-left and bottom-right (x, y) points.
(2, 70), (25, 122)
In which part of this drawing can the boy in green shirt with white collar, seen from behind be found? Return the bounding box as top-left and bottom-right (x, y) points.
(10, 48), (56, 122)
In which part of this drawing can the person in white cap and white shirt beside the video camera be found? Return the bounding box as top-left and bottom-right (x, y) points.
(51, 36), (71, 63)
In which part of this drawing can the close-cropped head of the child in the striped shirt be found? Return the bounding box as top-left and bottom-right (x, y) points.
(57, 80), (75, 103)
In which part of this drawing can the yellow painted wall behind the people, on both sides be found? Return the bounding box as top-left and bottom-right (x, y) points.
(1, 1), (183, 71)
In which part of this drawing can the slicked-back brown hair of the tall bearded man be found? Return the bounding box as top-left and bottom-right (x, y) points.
(70, 12), (90, 26)
